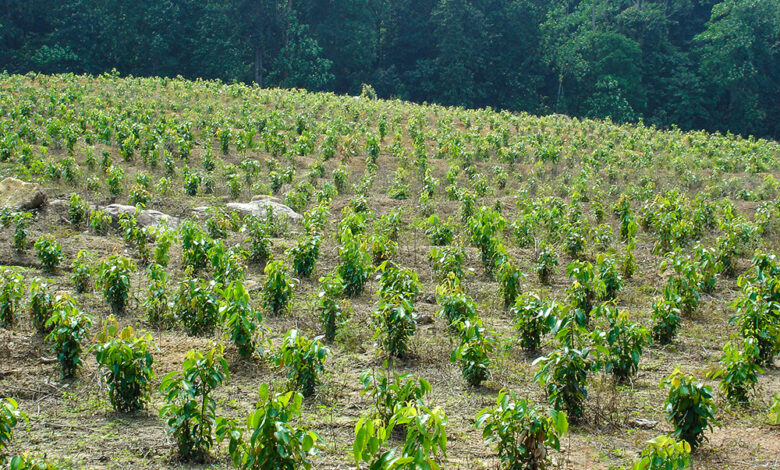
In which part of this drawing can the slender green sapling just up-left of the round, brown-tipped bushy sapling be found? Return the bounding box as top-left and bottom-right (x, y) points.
(46, 293), (92, 378)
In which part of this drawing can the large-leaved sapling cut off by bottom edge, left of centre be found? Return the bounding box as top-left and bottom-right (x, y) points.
(216, 384), (322, 470)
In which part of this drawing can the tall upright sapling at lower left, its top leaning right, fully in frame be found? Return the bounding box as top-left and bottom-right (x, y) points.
(160, 348), (230, 462)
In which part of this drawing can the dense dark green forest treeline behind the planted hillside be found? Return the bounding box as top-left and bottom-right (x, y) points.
(0, 0), (780, 138)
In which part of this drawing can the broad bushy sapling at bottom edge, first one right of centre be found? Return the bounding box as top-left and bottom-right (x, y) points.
(476, 389), (569, 470)
